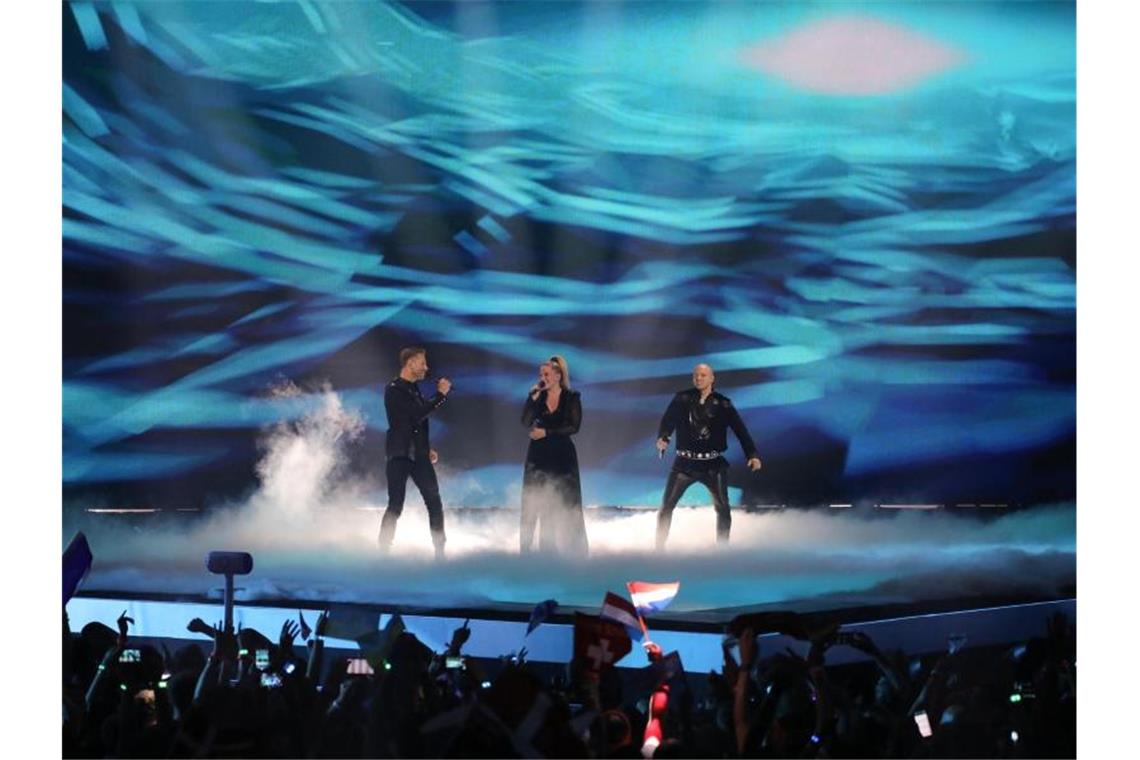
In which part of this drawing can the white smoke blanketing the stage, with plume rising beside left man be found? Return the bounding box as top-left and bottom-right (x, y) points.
(71, 385), (1075, 611)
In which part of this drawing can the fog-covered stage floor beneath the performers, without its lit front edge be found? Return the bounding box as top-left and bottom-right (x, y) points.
(64, 500), (1076, 630)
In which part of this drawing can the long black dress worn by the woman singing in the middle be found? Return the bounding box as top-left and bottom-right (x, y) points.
(519, 390), (589, 556)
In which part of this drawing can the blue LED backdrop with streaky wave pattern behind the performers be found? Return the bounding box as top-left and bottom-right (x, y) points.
(63, 1), (1076, 507)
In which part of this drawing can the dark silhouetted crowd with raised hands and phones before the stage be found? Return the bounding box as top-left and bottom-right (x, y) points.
(63, 601), (1076, 758)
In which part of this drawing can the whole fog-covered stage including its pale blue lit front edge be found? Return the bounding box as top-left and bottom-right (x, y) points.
(65, 498), (1076, 671)
